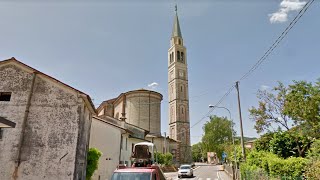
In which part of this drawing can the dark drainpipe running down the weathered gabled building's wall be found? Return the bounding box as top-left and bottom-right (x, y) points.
(13, 72), (37, 179)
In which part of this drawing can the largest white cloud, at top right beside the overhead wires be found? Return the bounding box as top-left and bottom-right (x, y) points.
(269, 0), (306, 23)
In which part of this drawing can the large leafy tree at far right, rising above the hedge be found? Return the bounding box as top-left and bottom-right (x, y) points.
(249, 81), (320, 157)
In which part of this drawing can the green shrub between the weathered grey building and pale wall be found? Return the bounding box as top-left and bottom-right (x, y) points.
(86, 148), (102, 180)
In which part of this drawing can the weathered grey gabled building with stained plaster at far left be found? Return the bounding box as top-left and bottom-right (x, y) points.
(0, 58), (95, 180)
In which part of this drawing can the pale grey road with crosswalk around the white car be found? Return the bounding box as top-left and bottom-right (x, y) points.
(165, 164), (231, 180)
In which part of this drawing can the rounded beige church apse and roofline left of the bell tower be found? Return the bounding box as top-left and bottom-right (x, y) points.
(97, 89), (162, 135)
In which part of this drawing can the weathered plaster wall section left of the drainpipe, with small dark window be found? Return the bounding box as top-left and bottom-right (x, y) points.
(0, 65), (32, 180)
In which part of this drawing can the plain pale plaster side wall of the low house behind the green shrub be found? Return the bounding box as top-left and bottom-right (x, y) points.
(90, 118), (122, 180)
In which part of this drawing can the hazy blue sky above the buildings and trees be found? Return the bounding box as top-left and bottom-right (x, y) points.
(0, 0), (320, 144)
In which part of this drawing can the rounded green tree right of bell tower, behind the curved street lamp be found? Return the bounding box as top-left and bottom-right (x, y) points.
(202, 116), (233, 157)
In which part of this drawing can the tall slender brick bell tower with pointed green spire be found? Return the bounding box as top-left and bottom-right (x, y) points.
(168, 5), (192, 164)
